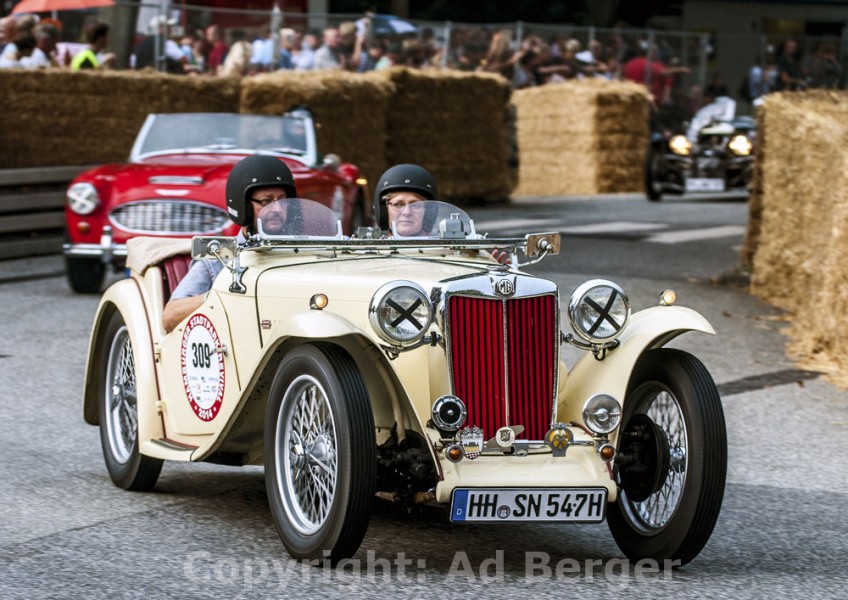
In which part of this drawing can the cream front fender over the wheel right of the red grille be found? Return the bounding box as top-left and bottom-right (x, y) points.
(557, 306), (715, 423)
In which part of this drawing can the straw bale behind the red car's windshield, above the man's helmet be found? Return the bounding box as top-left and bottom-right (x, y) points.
(241, 71), (394, 192)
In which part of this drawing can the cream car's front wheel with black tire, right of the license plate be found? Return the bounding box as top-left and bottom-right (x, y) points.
(607, 348), (727, 566)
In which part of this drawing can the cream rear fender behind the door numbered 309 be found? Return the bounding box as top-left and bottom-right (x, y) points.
(83, 279), (162, 443)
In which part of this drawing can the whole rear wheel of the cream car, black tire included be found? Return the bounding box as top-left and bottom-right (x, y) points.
(98, 310), (163, 491)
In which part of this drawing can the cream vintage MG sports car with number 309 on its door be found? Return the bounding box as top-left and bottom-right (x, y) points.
(84, 199), (727, 564)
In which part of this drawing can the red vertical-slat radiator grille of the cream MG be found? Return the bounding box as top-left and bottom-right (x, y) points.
(448, 294), (558, 440)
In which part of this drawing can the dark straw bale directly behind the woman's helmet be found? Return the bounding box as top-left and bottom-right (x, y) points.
(384, 68), (512, 200)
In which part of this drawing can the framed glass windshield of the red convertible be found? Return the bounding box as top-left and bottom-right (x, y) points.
(138, 113), (309, 155)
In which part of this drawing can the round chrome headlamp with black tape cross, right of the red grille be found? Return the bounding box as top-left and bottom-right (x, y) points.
(568, 279), (630, 344)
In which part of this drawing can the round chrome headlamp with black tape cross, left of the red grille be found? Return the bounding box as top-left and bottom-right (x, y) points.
(368, 281), (433, 345)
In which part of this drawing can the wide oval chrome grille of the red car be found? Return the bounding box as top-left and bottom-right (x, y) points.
(109, 200), (229, 234)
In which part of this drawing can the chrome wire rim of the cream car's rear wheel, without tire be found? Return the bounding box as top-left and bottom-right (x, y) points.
(106, 325), (138, 464)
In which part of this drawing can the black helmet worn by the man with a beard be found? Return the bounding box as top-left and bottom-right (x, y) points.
(227, 154), (297, 227)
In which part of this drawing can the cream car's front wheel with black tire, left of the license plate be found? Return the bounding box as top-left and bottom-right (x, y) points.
(265, 344), (377, 564)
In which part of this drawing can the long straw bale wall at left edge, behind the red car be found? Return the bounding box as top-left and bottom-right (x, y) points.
(0, 69), (239, 169)
